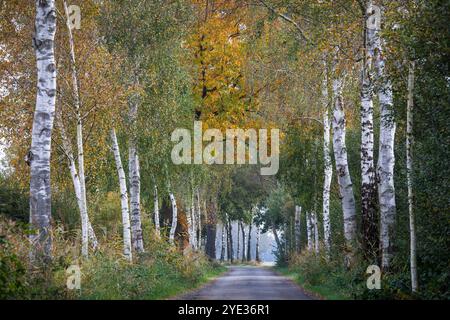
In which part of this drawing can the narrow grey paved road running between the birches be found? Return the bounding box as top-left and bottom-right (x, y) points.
(177, 266), (312, 300)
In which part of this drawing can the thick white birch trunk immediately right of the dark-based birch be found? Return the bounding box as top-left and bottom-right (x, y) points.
(374, 8), (396, 270)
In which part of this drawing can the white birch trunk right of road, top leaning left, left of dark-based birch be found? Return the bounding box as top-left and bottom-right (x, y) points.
(333, 77), (356, 267)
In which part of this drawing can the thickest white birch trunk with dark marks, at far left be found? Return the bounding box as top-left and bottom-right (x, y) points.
(27, 0), (56, 262)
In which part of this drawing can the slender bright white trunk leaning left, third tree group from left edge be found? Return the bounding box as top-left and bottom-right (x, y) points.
(111, 129), (132, 261)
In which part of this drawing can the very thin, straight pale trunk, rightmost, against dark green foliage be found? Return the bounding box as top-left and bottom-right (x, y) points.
(406, 61), (418, 292)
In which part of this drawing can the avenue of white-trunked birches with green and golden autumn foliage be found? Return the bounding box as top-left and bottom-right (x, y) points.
(0, 0), (450, 298)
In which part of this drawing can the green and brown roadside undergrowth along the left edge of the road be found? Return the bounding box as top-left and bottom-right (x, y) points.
(0, 218), (225, 300)
